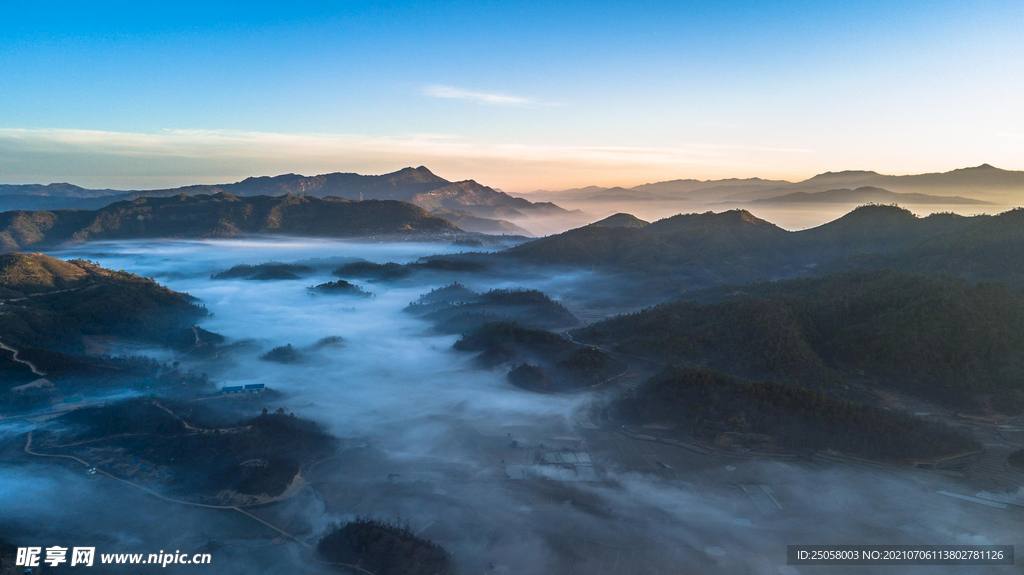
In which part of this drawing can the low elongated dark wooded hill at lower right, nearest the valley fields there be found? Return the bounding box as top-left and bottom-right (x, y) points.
(611, 367), (981, 462)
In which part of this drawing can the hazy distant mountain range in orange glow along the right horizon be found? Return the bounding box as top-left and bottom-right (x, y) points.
(524, 164), (1024, 205)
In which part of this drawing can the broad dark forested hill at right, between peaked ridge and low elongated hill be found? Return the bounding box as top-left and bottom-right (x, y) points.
(575, 270), (1024, 410)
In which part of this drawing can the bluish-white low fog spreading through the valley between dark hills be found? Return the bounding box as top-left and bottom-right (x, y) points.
(0, 235), (1022, 574)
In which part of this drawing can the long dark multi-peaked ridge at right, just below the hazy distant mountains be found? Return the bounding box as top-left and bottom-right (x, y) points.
(504, 206), (1024, 285)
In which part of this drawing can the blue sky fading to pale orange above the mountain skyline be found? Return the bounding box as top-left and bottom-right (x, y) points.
(0, 0), (1024, 192)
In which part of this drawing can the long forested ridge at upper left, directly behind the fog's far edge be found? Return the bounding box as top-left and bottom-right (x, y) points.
(0, 193), (460, 252)
